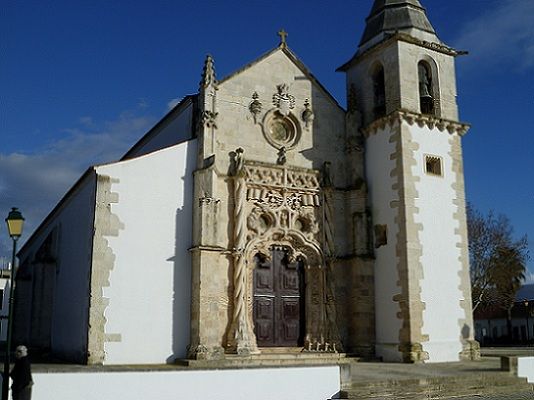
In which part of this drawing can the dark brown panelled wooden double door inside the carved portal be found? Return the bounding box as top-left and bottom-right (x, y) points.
(253, 246), (305, 347)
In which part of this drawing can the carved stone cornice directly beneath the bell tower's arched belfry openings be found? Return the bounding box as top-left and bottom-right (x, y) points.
(361, 110), (471, 137)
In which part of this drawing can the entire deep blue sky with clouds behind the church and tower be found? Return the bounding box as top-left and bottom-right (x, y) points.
(0, 0), (534, 272)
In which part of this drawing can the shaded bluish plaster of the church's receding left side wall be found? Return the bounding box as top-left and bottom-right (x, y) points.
(16, 171), (95, 362)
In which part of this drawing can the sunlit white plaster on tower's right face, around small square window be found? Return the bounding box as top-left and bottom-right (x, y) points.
(408, 125), (465, 362)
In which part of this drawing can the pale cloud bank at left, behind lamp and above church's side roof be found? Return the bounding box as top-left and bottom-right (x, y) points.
(0, 112), (154, 256)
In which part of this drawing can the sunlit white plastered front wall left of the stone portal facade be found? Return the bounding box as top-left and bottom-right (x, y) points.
(97, 140), (197, 364)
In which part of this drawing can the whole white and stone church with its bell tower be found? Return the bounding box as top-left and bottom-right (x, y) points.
(14, 0), (479, 365)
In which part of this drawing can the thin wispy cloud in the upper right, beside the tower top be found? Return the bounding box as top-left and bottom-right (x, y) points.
(455, 0), (534, 70)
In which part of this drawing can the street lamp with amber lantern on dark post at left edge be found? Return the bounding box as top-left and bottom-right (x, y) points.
(2, 207), (24, 400)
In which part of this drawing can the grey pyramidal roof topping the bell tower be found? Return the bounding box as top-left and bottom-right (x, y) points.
(360, 0), (440, 48)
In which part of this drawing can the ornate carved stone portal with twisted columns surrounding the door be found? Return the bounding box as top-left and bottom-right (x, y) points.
(228, 148), (341, 355)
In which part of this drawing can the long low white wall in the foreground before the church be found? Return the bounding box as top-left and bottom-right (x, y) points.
(22, 366), (340, 400)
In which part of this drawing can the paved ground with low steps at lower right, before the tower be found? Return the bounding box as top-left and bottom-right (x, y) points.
(341, 356), (534, 400)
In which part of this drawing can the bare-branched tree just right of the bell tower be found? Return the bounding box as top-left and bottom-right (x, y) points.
(467, 204), (529, 316)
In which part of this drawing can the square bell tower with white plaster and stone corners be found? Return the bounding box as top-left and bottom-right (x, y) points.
(339, 0), (478, 362)
